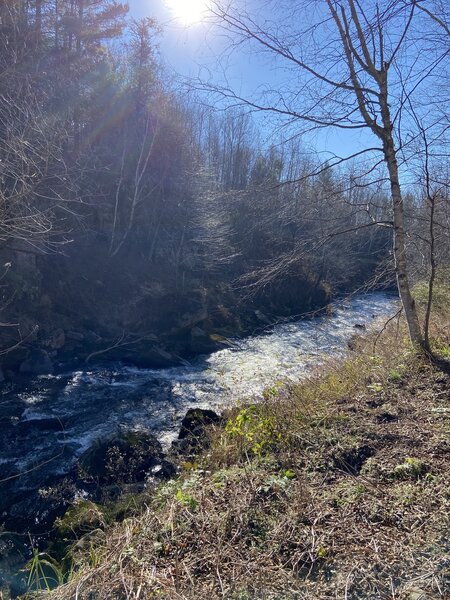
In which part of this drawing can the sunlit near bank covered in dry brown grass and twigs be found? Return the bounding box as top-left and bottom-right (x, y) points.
(23, 302), (450, 600)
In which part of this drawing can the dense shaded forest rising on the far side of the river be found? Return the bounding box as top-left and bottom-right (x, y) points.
(0, 0), (449, 372)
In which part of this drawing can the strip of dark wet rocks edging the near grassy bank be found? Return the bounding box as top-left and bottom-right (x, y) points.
(0, 409), (226, 598)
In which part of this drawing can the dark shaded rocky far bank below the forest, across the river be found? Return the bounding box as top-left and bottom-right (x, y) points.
(0, 252), (334, 383)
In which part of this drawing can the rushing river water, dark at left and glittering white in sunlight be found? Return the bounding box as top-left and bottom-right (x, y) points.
(0, 293), (397, 485)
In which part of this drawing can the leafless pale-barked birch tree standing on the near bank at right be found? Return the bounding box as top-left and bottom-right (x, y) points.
(208, 0), (450, 348)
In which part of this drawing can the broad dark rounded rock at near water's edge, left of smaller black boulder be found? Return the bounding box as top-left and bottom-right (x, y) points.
(79, 431), (164, 485)
